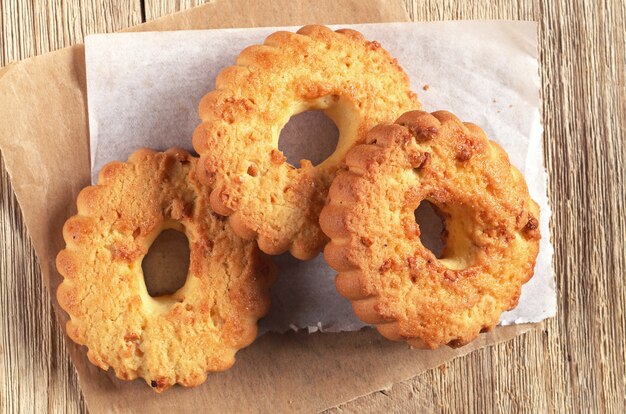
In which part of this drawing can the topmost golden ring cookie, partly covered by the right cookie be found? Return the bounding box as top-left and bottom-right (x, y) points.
(193, 26), (420, 259)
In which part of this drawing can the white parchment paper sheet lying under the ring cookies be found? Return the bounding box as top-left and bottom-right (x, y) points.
(85, 21), (556, 332)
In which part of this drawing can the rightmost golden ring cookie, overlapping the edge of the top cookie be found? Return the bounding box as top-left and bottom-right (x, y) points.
(320, 111), (540, 348)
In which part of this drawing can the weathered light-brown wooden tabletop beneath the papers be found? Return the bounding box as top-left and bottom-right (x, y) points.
(0, 0), (626, 413)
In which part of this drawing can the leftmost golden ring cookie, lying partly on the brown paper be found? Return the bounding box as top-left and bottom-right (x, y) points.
(57, 149), (274, 392)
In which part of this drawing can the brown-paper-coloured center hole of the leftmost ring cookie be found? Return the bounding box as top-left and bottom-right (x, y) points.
(141, 229), (189, 298)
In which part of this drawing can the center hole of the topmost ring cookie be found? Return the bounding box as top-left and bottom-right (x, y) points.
(278, 110), (339, 166)
